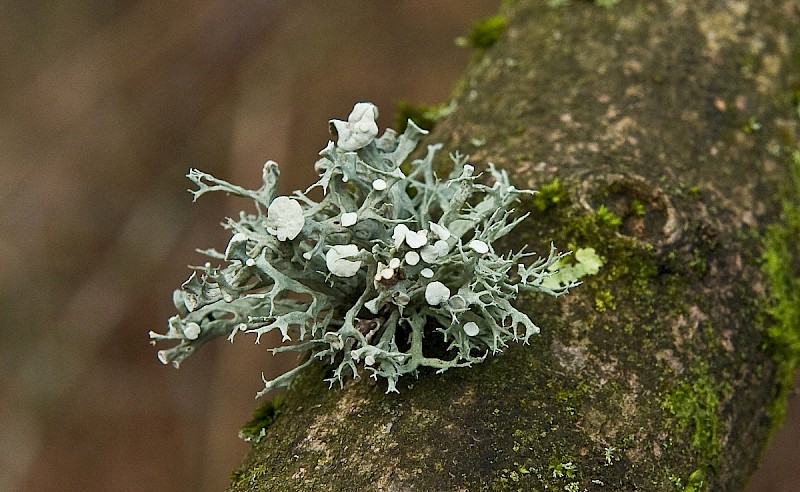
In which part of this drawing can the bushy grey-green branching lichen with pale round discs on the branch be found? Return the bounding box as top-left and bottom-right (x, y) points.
(150, 103), (577, 396)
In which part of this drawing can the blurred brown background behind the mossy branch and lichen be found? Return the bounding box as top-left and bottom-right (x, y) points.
(0, 0), (800, 492)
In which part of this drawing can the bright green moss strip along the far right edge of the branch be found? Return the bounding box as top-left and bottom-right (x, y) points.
(763, 150), (800, 425)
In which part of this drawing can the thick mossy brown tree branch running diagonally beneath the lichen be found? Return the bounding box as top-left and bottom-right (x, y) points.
(230, 0), (800, 491)
